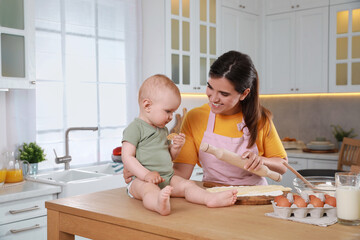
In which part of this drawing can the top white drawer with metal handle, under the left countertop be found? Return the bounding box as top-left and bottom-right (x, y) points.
(0, 194), (56, 225)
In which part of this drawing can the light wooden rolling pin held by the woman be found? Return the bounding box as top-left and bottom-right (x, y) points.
(200, 143), (282, 182)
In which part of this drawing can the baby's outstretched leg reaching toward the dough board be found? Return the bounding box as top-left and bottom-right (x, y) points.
(170, 176), (237, 207)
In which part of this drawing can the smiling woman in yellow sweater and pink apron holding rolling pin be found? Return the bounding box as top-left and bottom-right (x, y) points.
(174, 51), (287, 185)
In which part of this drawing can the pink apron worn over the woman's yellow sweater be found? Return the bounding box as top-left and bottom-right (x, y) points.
(199, 111), (267, 185)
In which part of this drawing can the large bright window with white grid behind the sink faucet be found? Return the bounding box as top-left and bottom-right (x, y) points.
(35, 0), (140, 169)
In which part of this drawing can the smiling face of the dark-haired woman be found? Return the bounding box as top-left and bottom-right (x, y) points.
(206, 77), (248, 115)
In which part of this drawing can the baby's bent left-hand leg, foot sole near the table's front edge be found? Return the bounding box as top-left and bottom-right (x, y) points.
(129, 178), (173, 215)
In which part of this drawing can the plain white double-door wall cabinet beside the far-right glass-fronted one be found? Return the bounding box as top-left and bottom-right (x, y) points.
(265, 7), (328, 94)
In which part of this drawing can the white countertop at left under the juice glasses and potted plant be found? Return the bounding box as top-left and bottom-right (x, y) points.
(0, 181), (61, 204)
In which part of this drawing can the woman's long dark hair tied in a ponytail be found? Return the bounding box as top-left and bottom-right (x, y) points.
(209, 51), (272, 148)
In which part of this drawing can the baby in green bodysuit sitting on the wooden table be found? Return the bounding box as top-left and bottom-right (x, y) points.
(122, 75), (237, 215)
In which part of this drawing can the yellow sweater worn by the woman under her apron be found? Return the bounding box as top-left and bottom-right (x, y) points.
(174, 104), (287, 165)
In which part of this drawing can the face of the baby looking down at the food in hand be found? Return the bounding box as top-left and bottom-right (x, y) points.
(149, 91), (181, 128)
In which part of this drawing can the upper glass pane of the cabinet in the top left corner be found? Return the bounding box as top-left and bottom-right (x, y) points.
(0, 0), (24, 30)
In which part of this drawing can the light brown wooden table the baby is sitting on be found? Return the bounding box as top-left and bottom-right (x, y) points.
(45, 188), (360, 240)
